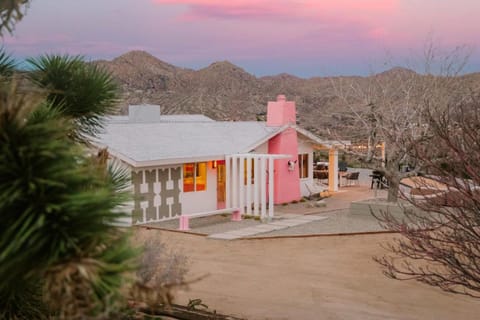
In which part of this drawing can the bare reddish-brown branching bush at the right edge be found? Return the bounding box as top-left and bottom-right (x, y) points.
(376, 96), (480, 298)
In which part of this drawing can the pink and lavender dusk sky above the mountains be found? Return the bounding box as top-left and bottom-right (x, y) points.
(3, 0), (480, 77)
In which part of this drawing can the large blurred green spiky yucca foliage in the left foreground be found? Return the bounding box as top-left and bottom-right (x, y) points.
(0, 84), (134, 319)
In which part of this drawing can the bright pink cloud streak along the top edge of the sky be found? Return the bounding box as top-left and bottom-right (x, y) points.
(151, 0), (400, 45)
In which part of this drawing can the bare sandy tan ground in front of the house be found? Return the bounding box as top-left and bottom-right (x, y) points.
(134, 229), (480, 319)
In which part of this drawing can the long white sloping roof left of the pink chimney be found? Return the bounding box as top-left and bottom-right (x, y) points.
(96, 119), (286, 166)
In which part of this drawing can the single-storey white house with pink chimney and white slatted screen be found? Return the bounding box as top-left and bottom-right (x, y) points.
(96, 95), (342, 224)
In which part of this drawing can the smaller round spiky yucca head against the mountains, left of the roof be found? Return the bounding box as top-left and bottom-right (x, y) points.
(27, 55), (118, 143)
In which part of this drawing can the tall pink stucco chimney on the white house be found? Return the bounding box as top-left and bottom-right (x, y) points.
(267, 95), (301, 204)
